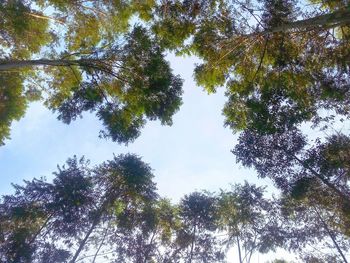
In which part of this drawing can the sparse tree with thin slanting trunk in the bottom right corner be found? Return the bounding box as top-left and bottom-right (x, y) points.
(279, 189), (350, 263)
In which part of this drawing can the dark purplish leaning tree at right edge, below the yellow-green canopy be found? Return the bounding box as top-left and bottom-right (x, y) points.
(233, 130), (350, 214)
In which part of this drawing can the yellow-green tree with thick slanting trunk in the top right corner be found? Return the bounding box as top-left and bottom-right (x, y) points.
(154, 0), (349, 110)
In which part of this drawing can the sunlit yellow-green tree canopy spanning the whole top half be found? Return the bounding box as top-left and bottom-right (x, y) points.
(0, 0), (350, 147)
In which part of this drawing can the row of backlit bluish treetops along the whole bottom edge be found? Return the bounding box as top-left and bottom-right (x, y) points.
(0, 159), (350, 263)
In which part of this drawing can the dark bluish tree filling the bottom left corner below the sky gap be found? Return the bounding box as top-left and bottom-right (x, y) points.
(0, 158), (94, 262)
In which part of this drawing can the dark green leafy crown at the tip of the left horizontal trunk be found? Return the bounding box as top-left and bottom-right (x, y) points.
(47, 26), (182, 143)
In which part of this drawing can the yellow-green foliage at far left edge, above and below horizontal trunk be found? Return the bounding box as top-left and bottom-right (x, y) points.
(0, 1), (51, 146)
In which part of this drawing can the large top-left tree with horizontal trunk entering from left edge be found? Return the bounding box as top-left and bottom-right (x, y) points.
(0, 0), (182, 143)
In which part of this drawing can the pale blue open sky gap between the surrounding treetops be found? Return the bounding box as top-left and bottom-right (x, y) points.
(0, 55), (290, 262)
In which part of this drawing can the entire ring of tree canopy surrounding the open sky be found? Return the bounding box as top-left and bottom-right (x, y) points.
(0, 0), (350, 263)
